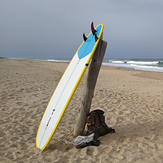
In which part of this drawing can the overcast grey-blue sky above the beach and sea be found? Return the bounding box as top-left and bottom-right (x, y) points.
(0, 0), (163, 59)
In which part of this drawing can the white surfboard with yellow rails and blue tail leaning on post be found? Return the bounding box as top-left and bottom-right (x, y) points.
(36, 23), (104, 150)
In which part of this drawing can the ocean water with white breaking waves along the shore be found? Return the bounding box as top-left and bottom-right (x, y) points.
(47, 59), (163, 73)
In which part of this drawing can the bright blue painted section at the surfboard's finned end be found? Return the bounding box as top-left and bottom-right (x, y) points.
(78, 25), (102, 59)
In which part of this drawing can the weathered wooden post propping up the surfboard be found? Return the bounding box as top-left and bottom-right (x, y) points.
(74, 40), (107, 136)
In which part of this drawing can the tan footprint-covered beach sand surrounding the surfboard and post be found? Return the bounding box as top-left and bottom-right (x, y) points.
(0, 58), (163, 163)
